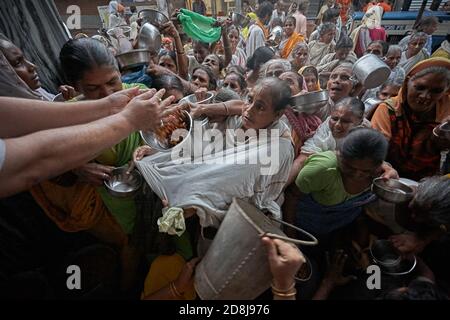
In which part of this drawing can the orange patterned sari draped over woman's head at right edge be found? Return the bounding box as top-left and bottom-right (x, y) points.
(372, 58), (450, 181)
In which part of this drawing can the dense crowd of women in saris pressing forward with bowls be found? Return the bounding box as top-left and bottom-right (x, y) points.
(0, 1), (450, 299)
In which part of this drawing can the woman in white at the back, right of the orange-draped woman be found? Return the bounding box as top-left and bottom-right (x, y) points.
(308, 23), (336, 65)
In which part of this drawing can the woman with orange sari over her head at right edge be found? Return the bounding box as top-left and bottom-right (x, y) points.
(372, 58), (450, 180)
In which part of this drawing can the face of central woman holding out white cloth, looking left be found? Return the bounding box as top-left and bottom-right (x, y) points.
(242, 87), (281, 130)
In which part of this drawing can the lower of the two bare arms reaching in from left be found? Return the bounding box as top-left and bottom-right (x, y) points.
(0, 90), (173, 197)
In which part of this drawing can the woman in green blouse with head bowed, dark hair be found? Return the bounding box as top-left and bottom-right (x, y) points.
(283, 128), (388, 238)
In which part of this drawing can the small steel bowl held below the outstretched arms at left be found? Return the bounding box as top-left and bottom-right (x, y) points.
(103, 166), (143, 198)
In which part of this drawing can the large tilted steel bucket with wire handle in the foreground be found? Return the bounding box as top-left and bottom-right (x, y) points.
(194, 199), (318, 300)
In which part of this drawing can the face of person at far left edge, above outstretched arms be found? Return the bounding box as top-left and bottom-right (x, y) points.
(0, 43), (41, 90)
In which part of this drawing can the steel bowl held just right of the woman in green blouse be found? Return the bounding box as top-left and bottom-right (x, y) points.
(372, 178), (414, 203)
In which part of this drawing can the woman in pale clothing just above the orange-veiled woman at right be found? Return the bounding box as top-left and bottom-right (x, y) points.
(399, 32), (430, 74)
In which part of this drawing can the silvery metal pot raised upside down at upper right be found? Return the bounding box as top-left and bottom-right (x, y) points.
(352, 54), (391, 89)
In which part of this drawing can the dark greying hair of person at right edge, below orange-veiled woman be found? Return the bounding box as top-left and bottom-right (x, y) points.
(413, 176), (450, 225)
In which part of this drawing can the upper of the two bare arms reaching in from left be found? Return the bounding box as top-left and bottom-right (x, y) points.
(0, 88), (139, 138)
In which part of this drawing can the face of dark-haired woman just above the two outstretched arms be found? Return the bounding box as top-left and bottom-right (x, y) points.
(75, 66), (122, 100)
